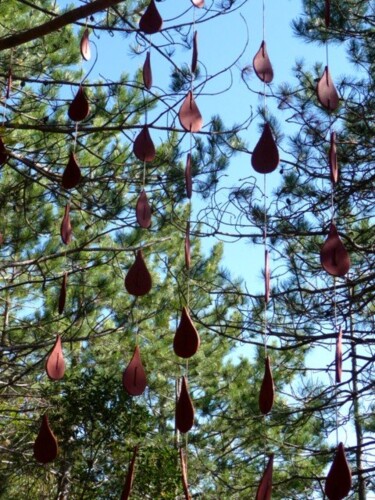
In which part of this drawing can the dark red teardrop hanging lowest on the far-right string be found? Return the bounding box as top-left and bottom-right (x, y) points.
(324, 443), (352, 500)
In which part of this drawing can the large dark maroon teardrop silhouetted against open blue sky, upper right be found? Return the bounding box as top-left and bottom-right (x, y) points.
(251, 122), (280, 174)
